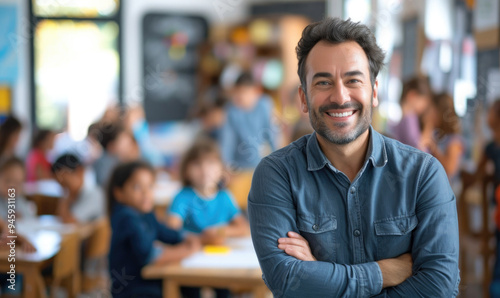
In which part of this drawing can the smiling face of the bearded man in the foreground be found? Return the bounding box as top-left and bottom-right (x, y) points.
(299, 41), (378, 145)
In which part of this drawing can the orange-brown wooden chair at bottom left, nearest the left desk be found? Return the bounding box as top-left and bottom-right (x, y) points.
(45, 233), (81, 298)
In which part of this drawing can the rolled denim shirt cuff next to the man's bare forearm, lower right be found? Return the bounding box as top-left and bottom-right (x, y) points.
(352, 262), (383, 297)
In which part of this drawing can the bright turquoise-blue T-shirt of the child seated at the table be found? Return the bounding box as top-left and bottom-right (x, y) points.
(170, 187), (240, 233)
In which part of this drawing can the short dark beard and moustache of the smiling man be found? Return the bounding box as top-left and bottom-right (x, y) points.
(306, 91), (373, 145)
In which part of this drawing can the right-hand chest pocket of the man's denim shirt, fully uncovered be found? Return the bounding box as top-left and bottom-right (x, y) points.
(374, 215), (418, 260)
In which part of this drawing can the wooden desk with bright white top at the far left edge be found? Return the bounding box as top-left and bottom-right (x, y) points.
(0, 231), (61, 298)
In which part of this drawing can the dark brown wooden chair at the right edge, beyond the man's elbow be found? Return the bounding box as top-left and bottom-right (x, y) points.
(457, 172), (495, 297)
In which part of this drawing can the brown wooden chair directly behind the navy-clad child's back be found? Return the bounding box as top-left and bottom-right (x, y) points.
(82, 217), (111, 292)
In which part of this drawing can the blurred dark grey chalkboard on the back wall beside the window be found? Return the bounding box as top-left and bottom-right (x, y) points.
(142, 13), (208, 123)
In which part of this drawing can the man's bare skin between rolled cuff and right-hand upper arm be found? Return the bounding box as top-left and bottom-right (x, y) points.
(377, 253), (413, 288)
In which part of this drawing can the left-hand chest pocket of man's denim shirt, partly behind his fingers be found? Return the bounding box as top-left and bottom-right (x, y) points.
(297, 215), (337, 262)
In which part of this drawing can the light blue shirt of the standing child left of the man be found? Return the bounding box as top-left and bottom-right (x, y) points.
(220, 96), (276, 169)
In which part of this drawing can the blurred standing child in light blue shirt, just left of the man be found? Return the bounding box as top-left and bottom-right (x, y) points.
(220, 72), (276, 170)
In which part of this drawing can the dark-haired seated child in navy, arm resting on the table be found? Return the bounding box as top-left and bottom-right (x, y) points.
(106, 161), (201, 298)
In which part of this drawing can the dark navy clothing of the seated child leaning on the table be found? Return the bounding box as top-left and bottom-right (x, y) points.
(108, 203), (182, 298)
